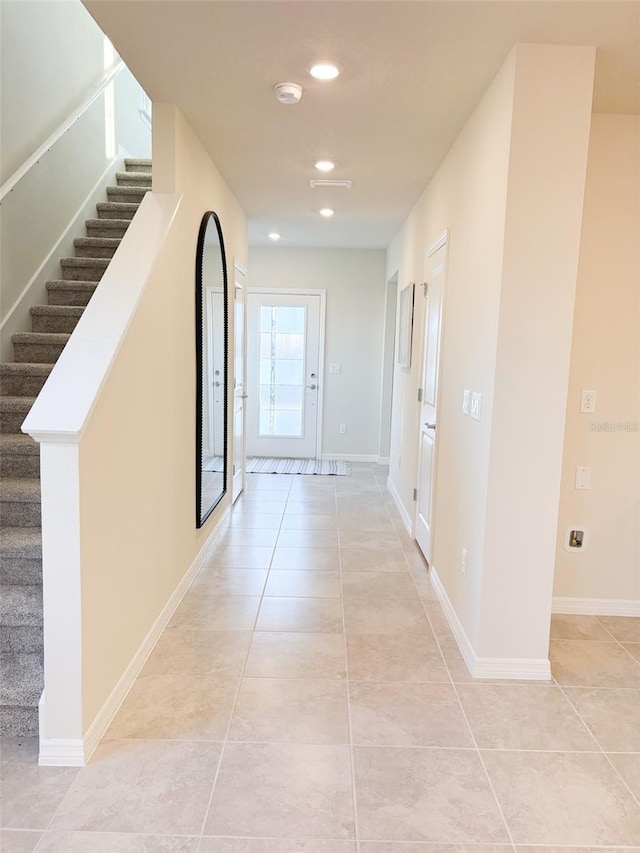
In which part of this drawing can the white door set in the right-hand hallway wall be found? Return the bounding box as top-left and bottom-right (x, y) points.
(415, 232), (447, 563)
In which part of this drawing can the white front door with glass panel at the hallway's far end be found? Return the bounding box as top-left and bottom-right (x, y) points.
(247, 290), (324, 459)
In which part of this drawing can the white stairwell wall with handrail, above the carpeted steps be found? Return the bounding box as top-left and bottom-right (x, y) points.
(0, 0), (151, 360)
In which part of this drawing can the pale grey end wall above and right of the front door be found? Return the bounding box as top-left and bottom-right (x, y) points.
(249, 247), (386, 459)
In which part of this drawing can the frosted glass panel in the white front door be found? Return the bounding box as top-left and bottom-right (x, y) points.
(258, 305), (306, 437)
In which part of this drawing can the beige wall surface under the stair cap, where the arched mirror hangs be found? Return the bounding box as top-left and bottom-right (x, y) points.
(80, 104), (247, 731)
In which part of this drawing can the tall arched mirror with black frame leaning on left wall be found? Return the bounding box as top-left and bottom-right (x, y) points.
(196, 211), (229, 527)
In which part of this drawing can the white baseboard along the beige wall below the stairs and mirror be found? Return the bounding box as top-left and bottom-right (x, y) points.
(38, 507), (231, 767)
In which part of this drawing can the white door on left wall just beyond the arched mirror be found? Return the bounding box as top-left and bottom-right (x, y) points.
(231, 261), (247, 501)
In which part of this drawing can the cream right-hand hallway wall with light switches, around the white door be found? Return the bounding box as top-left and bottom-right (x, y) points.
(387, 45), (594, 677)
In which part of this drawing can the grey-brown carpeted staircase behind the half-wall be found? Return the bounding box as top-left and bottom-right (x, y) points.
(0, 159), (151, 736)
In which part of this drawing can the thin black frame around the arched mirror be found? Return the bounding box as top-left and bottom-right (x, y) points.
(196, 210), (229, 529)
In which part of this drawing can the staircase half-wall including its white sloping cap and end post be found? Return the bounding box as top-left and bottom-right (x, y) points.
(25, 104), (247, 763)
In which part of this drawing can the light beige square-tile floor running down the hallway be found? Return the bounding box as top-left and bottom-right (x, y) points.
(0, 465), (640, 853)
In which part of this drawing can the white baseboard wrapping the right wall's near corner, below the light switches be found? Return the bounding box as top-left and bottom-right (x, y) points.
(429, 566), (551, 681)
